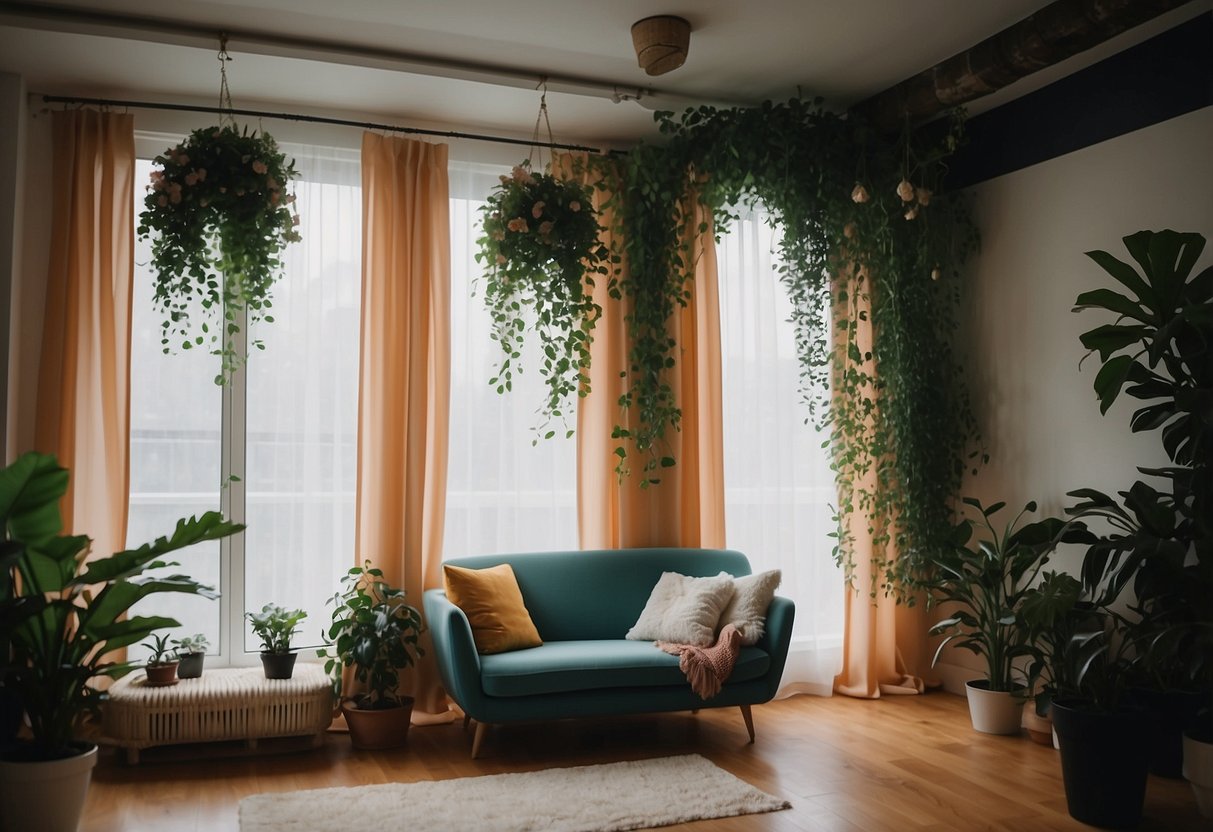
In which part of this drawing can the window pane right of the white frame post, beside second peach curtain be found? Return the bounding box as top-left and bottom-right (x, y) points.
(243, 147), (361, 651)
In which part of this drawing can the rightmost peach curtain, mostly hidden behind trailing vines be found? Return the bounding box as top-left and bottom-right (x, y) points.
(833, 265), (930, 699)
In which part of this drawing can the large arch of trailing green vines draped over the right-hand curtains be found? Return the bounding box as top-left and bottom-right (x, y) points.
(562, 99), (979, 587)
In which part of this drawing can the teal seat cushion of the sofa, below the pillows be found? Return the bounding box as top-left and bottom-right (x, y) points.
(480, 639), (770, 696)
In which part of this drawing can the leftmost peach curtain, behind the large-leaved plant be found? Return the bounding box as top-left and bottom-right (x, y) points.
(34, 109), (135, 554)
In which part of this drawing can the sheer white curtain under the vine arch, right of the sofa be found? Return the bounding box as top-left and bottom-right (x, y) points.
(717, 212), (843, 696)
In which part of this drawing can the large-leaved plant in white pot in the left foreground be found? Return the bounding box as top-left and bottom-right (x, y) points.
(0, 452), (244, 831)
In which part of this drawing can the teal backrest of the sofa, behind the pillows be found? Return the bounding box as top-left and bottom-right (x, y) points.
(446, 548), (751, 642)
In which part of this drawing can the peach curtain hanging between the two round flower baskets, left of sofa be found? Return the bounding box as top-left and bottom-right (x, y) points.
(354, 133), (450, 722)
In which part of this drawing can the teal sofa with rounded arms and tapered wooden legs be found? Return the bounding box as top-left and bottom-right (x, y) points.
(425, 548), (796, 757)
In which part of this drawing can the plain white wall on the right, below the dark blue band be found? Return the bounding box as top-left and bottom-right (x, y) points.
(939, 107), (1213, 691)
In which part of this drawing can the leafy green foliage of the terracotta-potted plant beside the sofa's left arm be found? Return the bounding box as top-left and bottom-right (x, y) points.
(317, 560), (423, 710)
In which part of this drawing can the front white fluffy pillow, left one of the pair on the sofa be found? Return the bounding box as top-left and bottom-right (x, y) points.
(627, 572), (733, 648)
